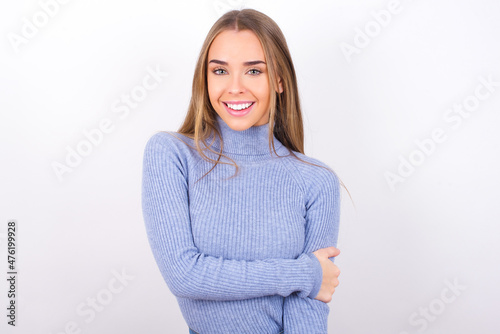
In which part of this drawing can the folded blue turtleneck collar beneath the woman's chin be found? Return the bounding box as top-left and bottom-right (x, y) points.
(213, 114), (288, 160)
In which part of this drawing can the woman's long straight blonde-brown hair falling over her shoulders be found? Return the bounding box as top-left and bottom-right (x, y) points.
(166, 8), (350, 201)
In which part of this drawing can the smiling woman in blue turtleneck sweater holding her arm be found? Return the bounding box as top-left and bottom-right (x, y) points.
(142, 9), (340, 334)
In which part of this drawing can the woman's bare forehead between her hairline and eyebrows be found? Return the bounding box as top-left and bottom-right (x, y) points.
(208, 30), (265, 63)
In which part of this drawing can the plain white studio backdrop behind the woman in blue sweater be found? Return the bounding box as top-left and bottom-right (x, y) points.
(0, 0), (500, 334)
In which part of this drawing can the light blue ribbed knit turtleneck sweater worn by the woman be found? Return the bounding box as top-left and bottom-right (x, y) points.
(142, 115), (340, 334)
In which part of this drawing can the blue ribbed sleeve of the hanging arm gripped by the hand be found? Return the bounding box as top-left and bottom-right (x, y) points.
(283, 167), (340, 334)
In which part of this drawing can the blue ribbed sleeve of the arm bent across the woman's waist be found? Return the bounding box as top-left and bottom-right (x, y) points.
(142, 133), (322, 300)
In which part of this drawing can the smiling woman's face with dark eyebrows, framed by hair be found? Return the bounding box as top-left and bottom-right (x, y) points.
(207, 30), (282, 131)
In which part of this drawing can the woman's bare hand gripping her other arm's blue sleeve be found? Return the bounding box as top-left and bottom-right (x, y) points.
(313, 247), (340, 303)
